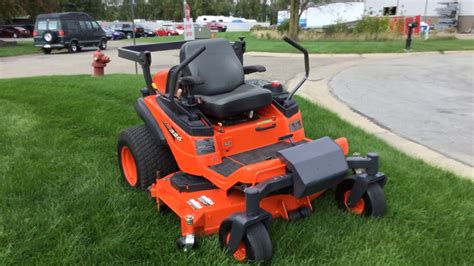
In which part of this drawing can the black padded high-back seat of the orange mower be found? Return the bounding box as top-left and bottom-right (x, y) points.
(180, 39), (272, 118)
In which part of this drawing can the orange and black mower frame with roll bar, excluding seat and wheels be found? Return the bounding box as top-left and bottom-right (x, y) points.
(118, 37), (387, 260)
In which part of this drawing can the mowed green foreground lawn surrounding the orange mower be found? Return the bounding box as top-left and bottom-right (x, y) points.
(0, 74), (474, 265)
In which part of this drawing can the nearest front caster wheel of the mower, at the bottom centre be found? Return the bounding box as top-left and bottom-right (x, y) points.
(219, 221), (272, 262)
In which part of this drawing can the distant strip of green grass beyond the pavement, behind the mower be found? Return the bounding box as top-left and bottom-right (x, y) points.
(138, 32), (474, 54)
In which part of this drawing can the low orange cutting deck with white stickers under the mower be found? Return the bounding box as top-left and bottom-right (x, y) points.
(150, 173), (322, 236)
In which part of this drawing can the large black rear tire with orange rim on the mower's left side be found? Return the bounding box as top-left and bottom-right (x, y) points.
(117, 125), (179, 190)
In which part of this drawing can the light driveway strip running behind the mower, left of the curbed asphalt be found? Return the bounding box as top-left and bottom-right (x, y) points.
(0, 41), (352, 83)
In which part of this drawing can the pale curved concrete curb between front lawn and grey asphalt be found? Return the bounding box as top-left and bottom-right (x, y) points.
(288, 54), (474, 181)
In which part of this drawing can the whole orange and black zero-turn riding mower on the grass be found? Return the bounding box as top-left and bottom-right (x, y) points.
(118, 38), (387, 262)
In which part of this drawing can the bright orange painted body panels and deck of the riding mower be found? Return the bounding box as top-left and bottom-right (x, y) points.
(144, 71), (348, 235)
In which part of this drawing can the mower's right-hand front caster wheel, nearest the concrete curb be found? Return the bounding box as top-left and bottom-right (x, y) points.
(336, 180), (385, 217)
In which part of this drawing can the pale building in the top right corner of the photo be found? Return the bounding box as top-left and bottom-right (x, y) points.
(364, 0), (474, 32)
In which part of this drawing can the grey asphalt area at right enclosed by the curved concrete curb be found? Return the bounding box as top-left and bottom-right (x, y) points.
(329, 53), (474, 166)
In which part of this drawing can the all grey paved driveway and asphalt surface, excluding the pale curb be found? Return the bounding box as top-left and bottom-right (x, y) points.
(0, 40), (474, 169)
